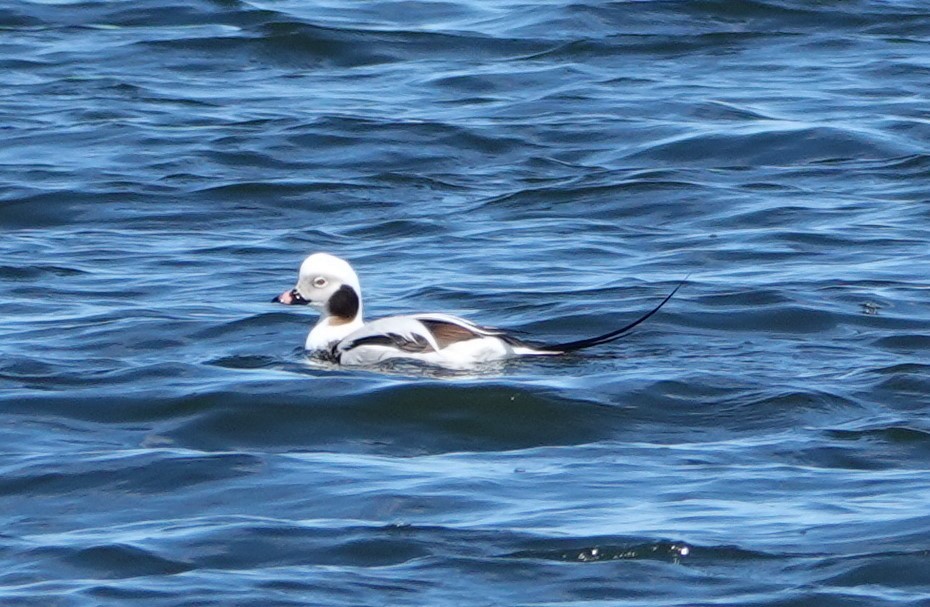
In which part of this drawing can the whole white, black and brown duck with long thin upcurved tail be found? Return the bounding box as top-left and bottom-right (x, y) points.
(273, 253), (680, 369)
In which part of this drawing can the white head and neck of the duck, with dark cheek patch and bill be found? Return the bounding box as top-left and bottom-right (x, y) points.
(273, 253), (362, 325)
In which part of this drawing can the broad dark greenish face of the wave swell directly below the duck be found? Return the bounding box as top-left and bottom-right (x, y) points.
(164, 381), (622, 455)
